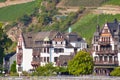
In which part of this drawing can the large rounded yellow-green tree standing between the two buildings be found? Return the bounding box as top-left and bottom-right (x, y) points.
(68, 51), (93, 75)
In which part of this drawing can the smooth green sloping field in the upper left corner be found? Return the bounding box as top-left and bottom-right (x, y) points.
(0, 1), (35, 21)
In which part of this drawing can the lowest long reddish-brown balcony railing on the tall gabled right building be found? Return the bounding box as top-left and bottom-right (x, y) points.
(94, 61), (118, 66)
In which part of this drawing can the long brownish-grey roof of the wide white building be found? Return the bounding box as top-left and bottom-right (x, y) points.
(22, 31), (85, 48)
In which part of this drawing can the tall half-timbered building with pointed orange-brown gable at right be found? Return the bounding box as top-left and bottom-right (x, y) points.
(92, 19), (120, 75)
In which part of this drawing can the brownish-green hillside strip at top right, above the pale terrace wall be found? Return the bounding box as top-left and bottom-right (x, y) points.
(61, 0), (120, 7)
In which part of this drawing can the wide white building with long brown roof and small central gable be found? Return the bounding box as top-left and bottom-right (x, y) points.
(16, 31), (87, 72)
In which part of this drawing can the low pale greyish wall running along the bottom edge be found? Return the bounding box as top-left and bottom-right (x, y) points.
(0, 76), (120, 80)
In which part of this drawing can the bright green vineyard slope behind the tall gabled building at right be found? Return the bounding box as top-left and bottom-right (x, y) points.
(71, 14), (120, 44)
